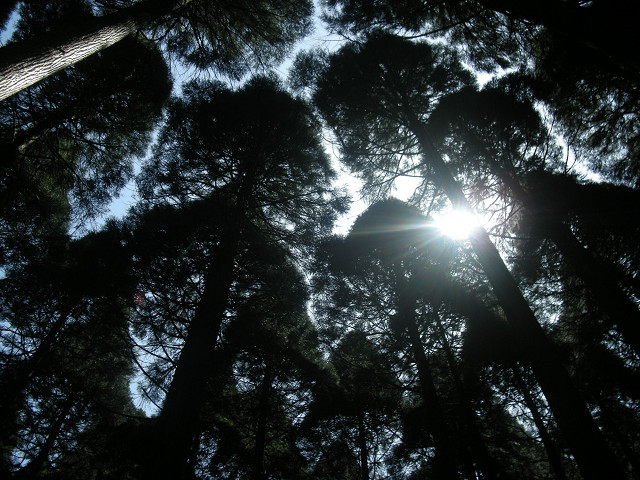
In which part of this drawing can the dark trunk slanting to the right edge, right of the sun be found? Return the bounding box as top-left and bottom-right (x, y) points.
(492, 167), (640, 355)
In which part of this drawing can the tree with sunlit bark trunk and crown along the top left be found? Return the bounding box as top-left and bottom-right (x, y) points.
(0, 0), (312, 100)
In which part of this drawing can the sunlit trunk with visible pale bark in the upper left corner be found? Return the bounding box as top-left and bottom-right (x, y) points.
(0, 0), (191, 100)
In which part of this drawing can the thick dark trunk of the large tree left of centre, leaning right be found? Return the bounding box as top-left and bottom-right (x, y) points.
(146, 219), (241, 480)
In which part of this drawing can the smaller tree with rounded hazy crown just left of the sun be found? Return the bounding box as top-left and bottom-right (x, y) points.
(312, 200), (468, 478)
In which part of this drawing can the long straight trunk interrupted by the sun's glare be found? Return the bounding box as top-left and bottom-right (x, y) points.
(407, 116), (625, 480)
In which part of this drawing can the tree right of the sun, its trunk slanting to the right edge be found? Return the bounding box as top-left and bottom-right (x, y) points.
(430, 86), (640, 358)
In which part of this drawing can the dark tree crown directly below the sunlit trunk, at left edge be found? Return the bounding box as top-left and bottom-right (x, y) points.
(0, 1), (171, 263)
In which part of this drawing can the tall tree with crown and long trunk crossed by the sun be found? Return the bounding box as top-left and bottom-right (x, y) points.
(314, 35), (622, 478)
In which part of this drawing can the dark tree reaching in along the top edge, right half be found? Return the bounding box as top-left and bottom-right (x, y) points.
(327, 0), (640, 73)
